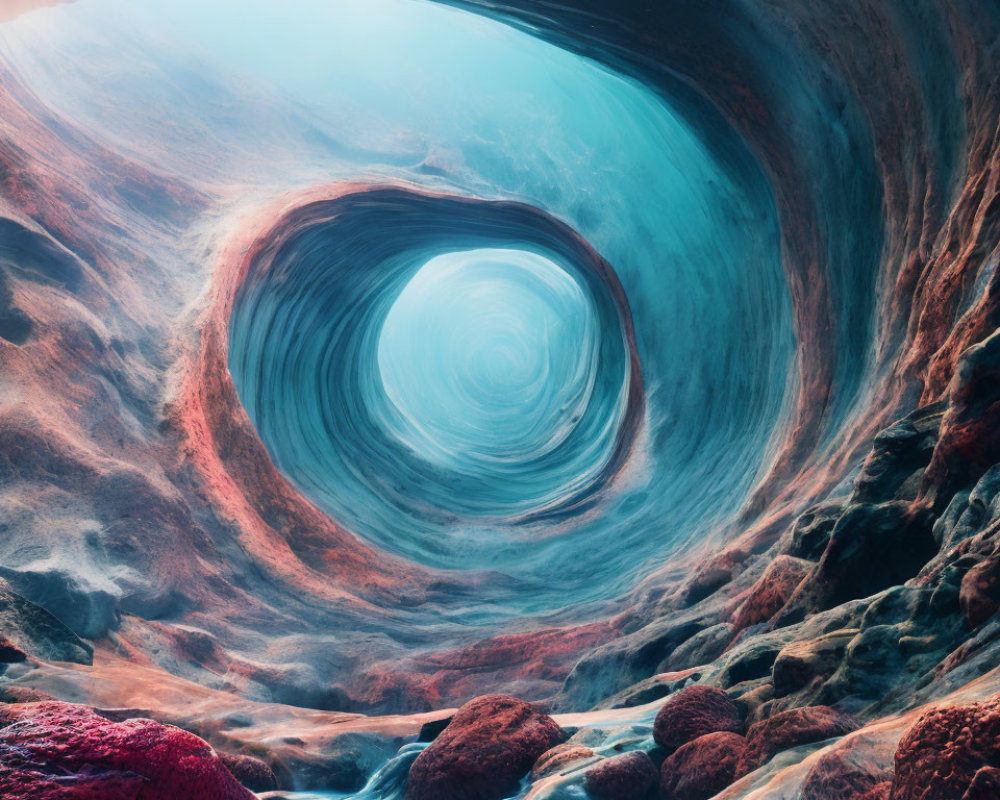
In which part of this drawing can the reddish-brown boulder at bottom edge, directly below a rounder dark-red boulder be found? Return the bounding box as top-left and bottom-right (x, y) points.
(660, 731), (746, 800)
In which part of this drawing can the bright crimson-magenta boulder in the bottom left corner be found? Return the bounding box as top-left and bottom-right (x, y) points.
(0, 702), (254, 800)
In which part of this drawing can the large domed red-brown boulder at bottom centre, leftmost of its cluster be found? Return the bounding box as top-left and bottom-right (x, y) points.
(406, 695), (565, 800)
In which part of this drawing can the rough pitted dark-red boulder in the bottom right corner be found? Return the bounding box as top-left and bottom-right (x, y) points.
(890, 695), (1000, 800)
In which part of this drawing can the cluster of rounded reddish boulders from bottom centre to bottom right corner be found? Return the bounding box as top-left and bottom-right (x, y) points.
(398, 686), (1000, 800)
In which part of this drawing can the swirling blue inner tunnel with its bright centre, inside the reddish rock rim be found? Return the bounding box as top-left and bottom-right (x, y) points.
(228, 186), (643, 567)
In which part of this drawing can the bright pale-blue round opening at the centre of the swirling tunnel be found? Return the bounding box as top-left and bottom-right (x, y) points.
(378, 250), (600, 477)
